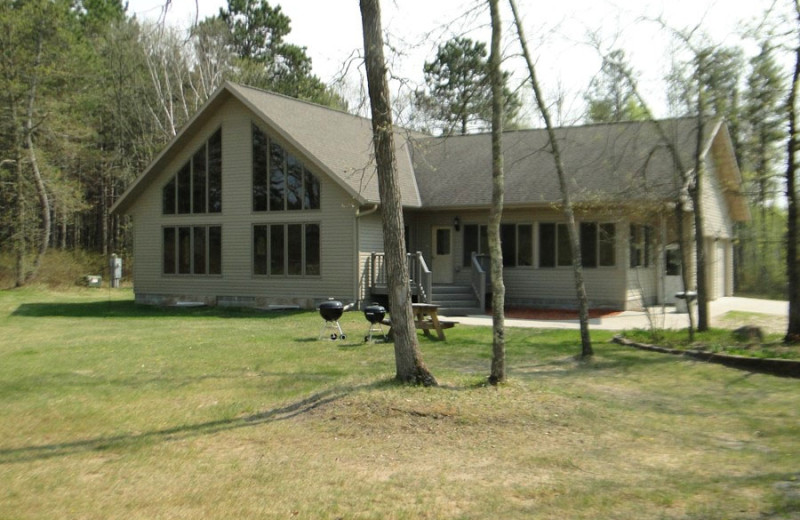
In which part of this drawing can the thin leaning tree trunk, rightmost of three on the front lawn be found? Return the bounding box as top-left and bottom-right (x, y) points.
(509, 0), (594, 358)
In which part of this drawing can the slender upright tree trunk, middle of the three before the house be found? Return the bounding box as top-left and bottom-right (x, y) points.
(488, 0), (506, 385)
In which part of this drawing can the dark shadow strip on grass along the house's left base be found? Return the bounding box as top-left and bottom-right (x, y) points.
(11, 300), (312, 318)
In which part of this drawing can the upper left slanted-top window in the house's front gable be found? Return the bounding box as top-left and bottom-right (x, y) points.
(161, 130), (222, 215)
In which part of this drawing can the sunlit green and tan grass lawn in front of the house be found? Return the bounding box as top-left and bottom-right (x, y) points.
(0, 289), (800, 520)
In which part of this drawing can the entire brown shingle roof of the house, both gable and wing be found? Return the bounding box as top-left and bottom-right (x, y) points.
(112, 83), (748, 220)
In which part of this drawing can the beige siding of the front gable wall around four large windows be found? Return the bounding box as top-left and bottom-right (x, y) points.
(133, 100), (356, 307)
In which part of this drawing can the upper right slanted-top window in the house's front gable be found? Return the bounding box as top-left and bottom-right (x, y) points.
(252, 125), (320, 211)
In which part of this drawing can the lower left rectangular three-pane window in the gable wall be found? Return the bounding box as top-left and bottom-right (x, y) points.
(163, 226), (222, 275)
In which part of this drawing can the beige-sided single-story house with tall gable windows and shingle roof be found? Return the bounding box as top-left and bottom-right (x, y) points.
(112, 83), (749, 312)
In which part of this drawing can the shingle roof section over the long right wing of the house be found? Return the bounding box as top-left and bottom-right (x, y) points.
(413, 119), (714, 208)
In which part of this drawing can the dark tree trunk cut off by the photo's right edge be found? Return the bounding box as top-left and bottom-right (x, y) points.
(784, 0), (800, 343)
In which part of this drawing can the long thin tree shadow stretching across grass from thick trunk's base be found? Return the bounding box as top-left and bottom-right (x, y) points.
(0, 380), (394, 465)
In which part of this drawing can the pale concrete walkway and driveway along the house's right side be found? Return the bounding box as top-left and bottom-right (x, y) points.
(454, 296), (789, 332)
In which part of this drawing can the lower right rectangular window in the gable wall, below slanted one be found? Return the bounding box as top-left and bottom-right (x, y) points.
(253, 224), (320, 276)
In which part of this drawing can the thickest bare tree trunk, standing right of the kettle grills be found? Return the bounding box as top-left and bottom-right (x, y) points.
(360, 0), (438, 386)
